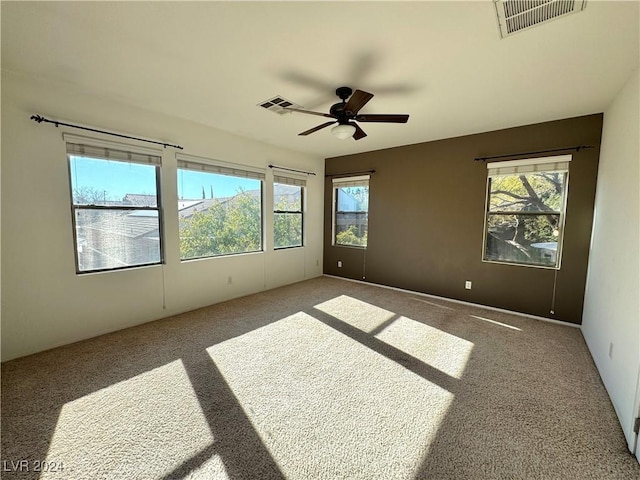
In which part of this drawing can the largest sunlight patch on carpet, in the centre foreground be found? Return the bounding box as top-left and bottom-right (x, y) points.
(207, 312), (453, 480)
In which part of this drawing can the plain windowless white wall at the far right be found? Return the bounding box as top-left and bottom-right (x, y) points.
(582, 71), (640, 448)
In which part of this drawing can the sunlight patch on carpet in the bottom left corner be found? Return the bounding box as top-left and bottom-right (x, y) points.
(40, 360), (218, 480)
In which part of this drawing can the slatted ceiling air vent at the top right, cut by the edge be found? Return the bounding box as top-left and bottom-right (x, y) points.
(494, 0), (587, 38)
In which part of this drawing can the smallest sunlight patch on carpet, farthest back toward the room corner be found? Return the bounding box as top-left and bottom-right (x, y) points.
(314, 295), (395, 332)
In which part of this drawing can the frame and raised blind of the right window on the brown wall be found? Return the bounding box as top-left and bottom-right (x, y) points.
(481, 155), (572, 270)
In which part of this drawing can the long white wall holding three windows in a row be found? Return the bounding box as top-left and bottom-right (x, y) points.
(1, 72), (324, 361)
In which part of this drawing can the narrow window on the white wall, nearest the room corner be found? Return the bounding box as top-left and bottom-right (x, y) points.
(273, 175), (306, 249)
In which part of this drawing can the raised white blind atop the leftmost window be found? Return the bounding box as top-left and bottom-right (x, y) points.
(63, 134), (162, 166)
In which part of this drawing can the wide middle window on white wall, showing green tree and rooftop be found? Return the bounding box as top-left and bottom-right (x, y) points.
(178, 156), (264, 260)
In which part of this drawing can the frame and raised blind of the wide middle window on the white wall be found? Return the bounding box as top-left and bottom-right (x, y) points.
(176, 154), (266, 263)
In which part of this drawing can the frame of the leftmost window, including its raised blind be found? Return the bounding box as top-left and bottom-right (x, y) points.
(63, 134), (165, 275)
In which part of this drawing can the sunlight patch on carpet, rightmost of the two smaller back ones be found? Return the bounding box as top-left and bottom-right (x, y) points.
(376, 317), (473, 378)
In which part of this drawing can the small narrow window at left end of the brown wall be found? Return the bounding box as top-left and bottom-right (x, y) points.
(333, 175), (369, 247)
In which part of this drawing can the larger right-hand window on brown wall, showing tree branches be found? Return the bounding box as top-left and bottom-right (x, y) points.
(483, 155), (571, 269)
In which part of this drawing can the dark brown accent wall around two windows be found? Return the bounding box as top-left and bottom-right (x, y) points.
(324, 114), (603, 324)
